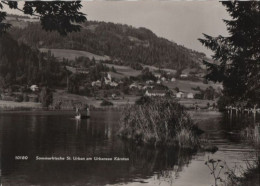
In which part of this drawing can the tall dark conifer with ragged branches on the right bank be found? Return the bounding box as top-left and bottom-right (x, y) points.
(199, 1), (260, 105)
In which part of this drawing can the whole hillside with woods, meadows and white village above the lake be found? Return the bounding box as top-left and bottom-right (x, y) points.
(0, 18), (221, 108)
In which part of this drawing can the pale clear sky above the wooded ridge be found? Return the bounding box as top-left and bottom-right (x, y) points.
(5, 0), (230, 56)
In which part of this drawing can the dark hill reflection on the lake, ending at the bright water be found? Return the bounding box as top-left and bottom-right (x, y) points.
(1, 111), (195, 186)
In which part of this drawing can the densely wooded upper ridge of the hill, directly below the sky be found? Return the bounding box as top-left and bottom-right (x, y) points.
(10, 21), (205, 69)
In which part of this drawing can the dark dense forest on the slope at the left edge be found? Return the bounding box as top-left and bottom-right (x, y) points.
(0, 34), (67, 87)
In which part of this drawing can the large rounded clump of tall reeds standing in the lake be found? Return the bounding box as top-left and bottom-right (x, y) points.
(119, 97), (199, 148)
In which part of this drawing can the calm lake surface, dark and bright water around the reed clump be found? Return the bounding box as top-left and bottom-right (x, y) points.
(0, 111), (258, 186)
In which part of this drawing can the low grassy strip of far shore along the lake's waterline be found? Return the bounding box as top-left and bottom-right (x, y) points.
(0, 90), (218, 111)
